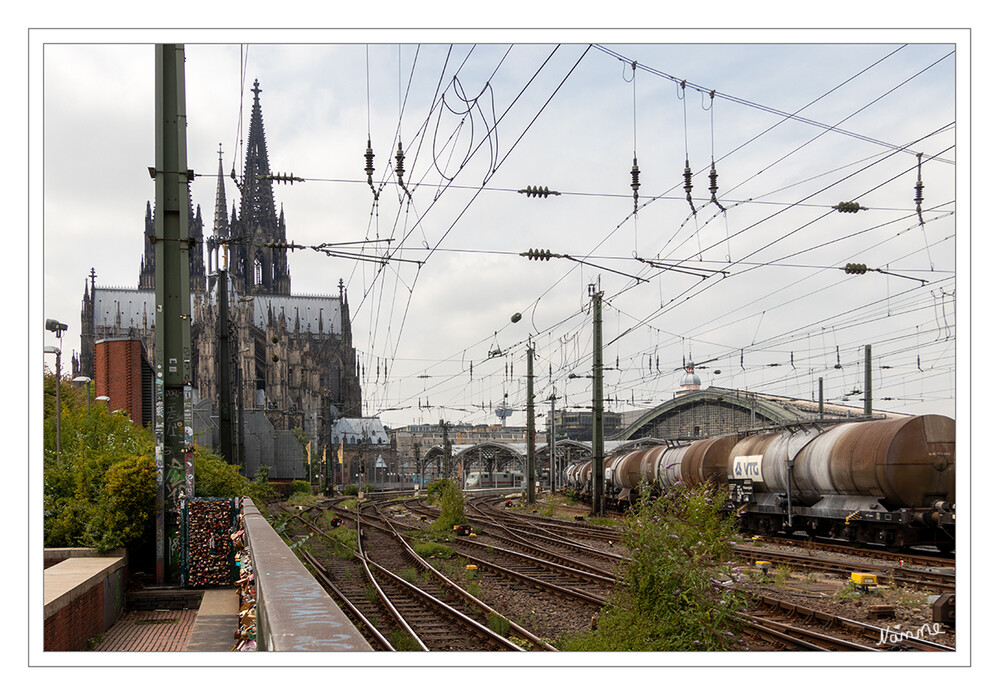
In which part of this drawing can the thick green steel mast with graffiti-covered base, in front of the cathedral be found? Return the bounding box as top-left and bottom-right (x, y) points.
(150, 44), (194, 584)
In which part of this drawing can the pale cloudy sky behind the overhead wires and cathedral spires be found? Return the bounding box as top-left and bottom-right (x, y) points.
(32, 31), (969, 425)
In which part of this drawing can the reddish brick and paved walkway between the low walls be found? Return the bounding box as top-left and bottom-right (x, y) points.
(94, 589), (239, 652)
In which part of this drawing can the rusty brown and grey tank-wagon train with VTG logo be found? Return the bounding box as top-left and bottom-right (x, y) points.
(566, 415), (956, 551)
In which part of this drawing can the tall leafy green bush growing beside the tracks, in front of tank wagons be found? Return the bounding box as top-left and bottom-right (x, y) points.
(560, 486), (746, 651)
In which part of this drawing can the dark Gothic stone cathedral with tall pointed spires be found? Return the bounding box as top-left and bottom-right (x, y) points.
(73, 81), (361, 464)
